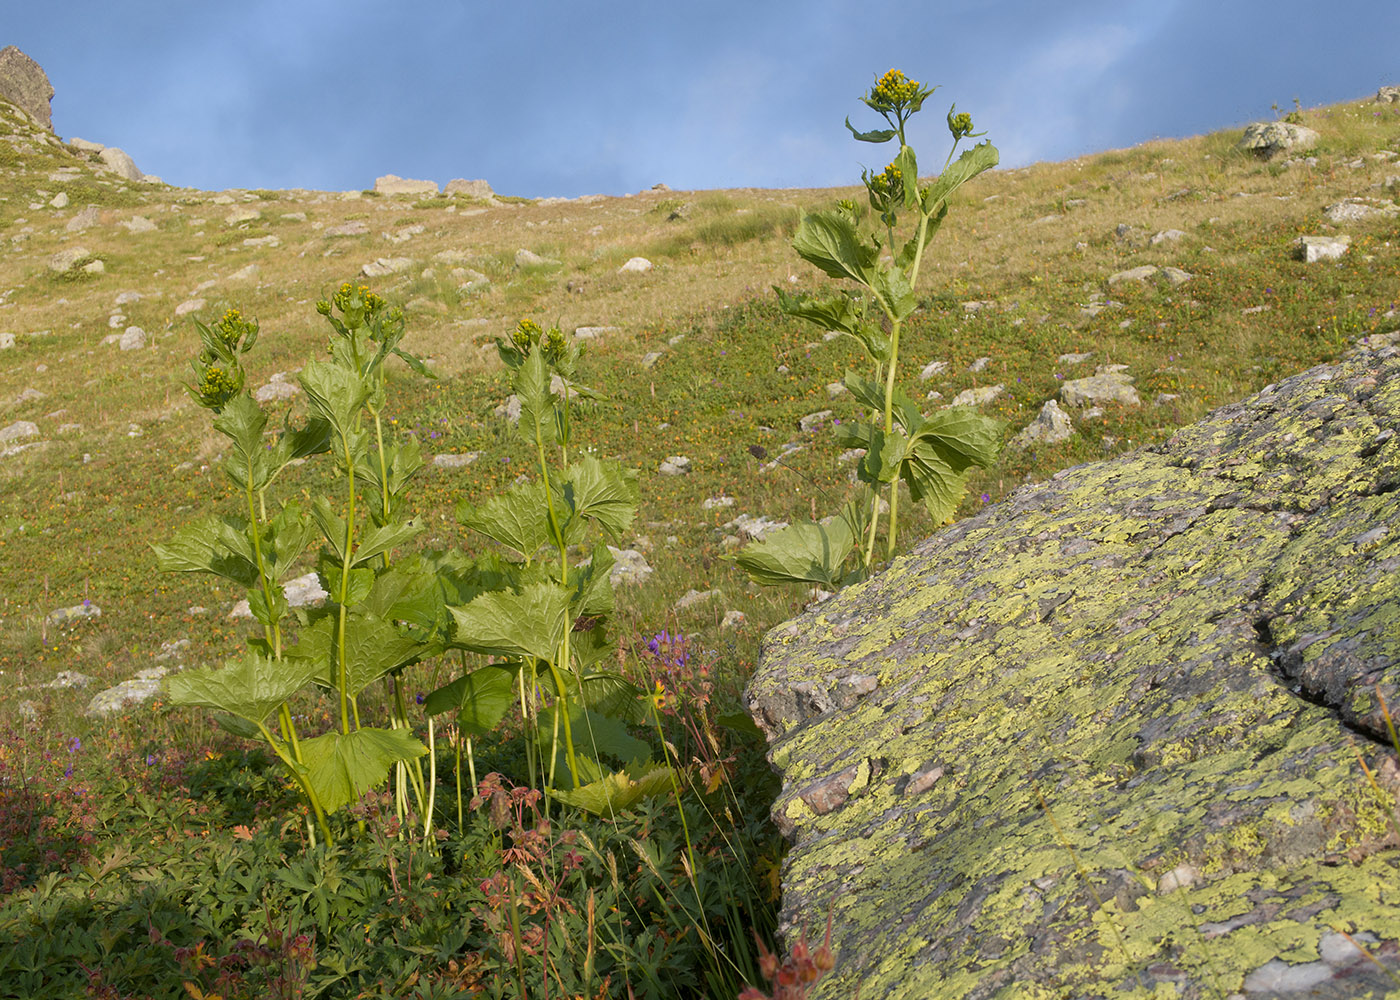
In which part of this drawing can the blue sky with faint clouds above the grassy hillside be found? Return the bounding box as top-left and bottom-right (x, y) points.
(0, 0), (1400, 196)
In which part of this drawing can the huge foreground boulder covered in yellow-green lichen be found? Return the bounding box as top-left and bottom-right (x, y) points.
(746, 338), (1400, 1000)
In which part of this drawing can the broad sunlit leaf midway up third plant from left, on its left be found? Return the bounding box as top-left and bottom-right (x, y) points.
(448, 583), (573, 661)
